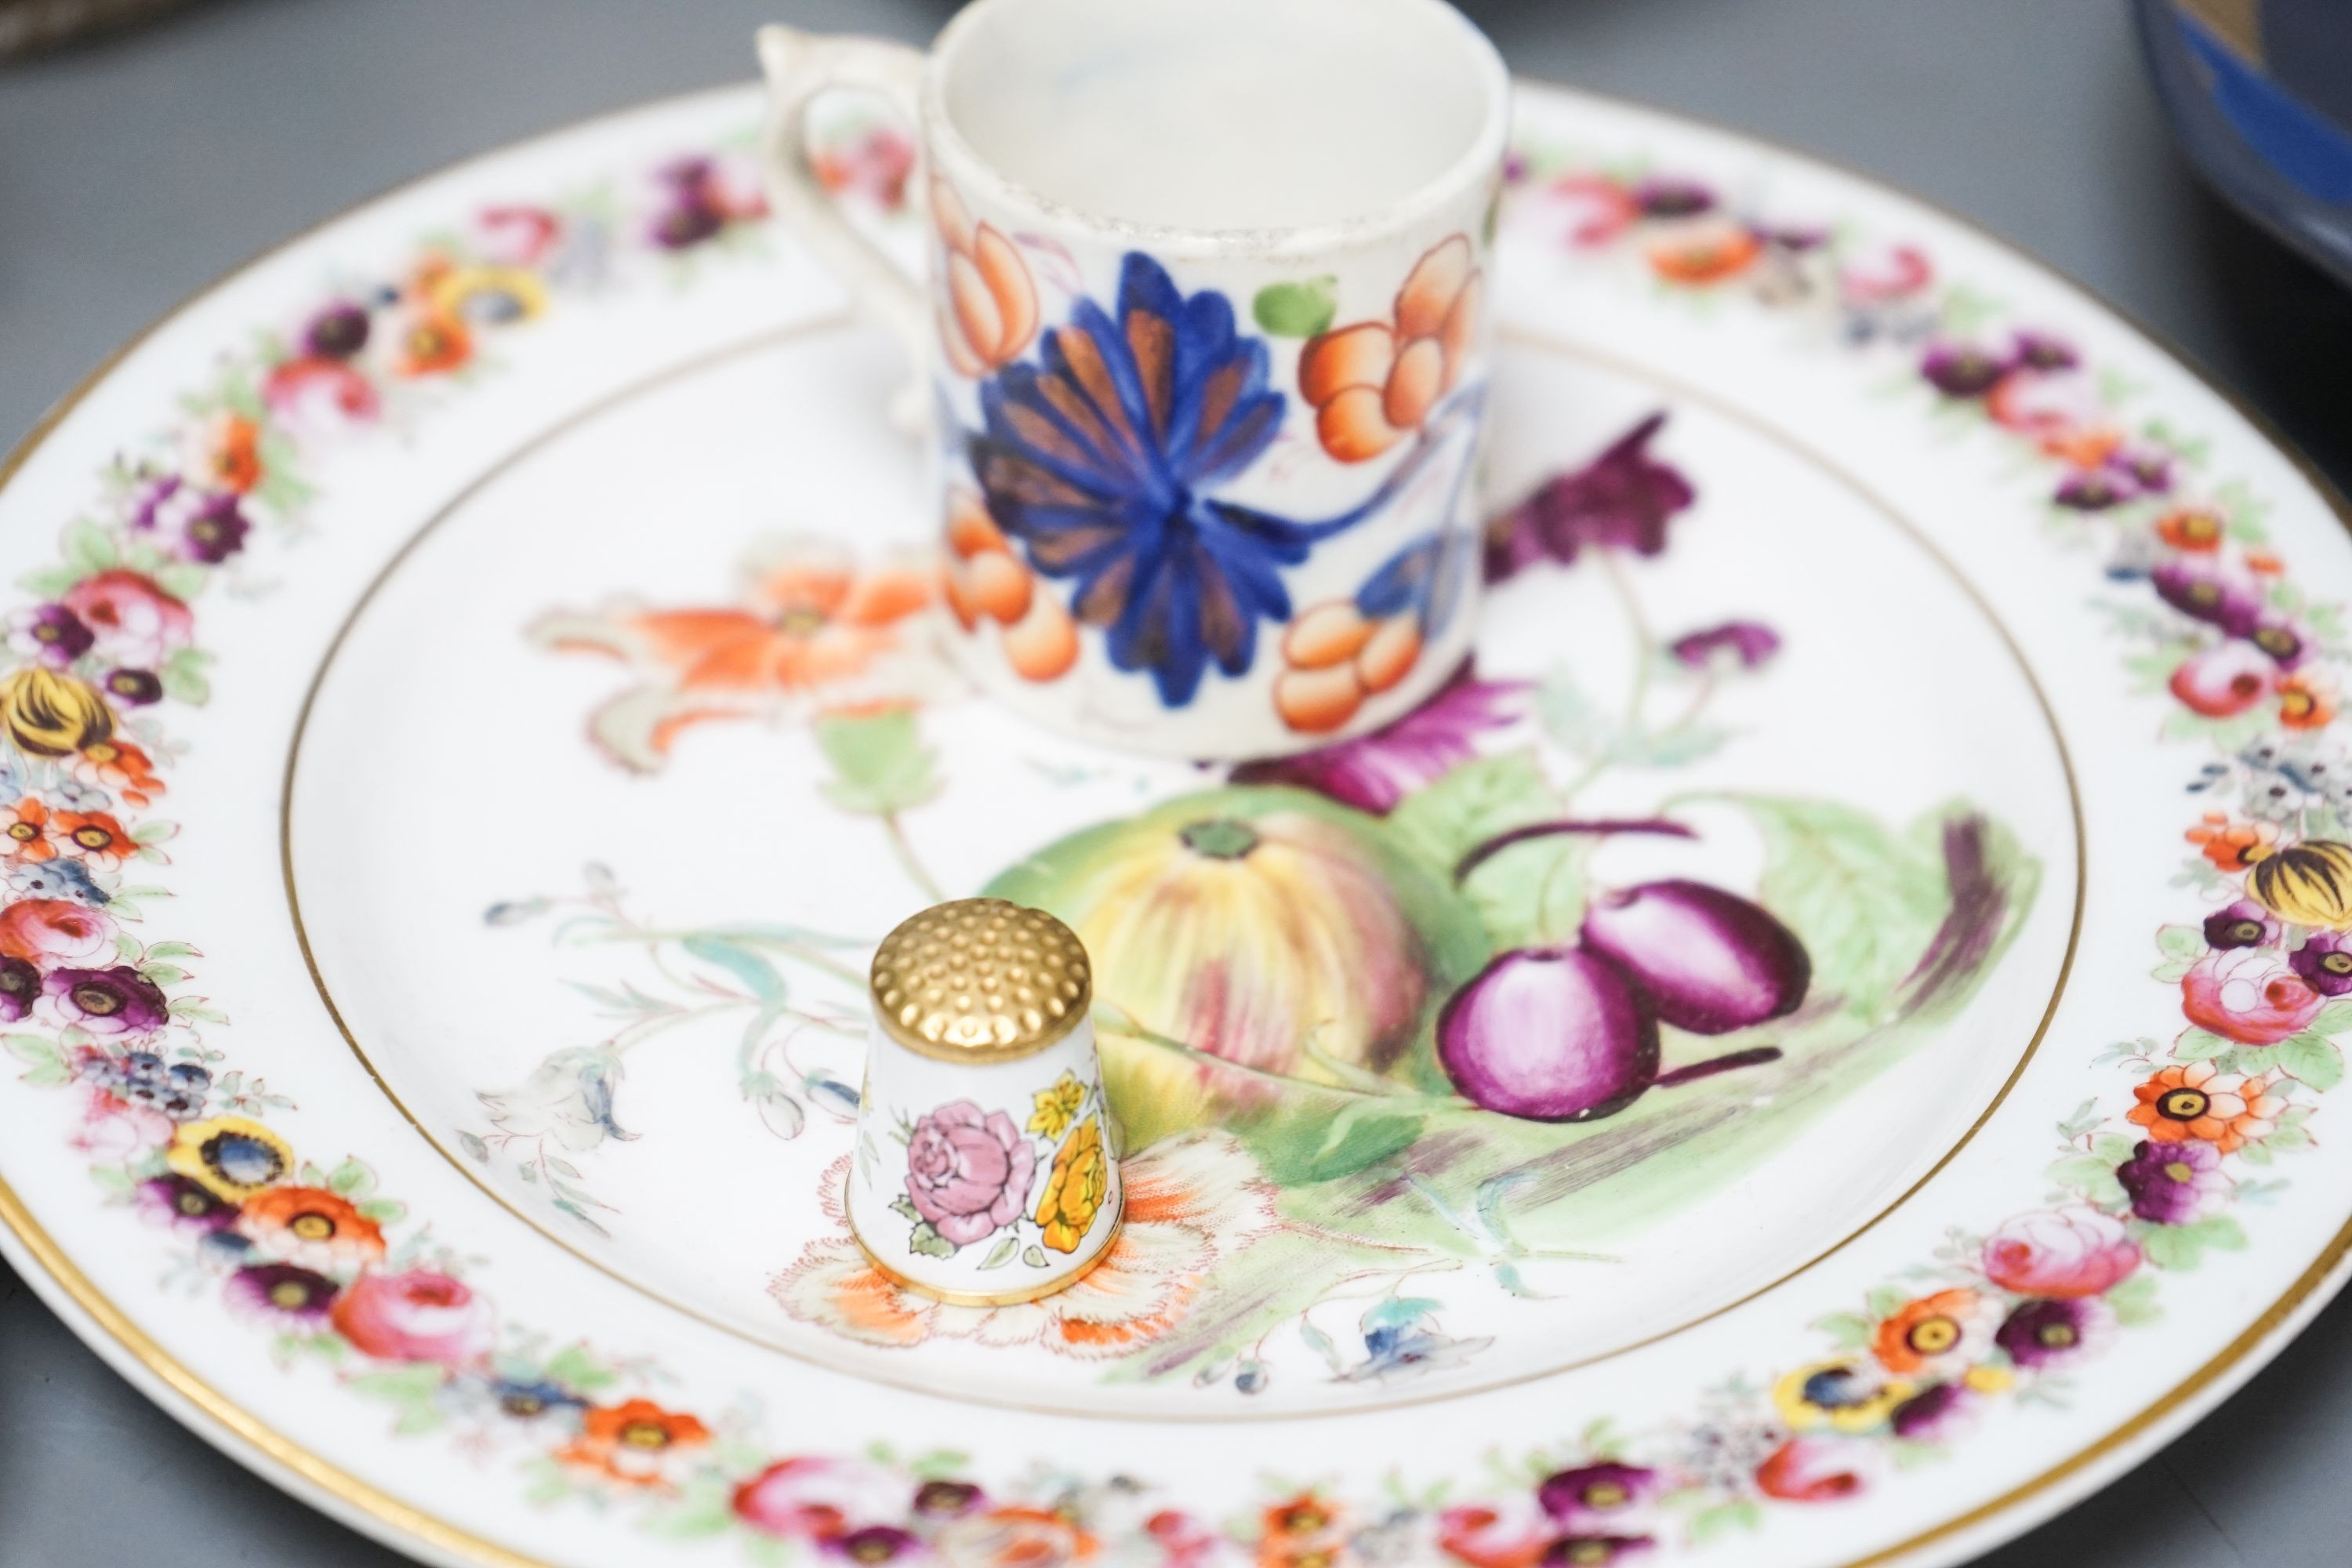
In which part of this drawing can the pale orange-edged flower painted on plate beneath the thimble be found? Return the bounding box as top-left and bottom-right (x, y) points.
(769, 1131), (1277, 1361)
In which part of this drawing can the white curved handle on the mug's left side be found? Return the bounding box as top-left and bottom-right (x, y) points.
(760, 24), (931, 430)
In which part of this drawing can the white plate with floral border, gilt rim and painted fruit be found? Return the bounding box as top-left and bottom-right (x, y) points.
(0, 76), (2352, 1568)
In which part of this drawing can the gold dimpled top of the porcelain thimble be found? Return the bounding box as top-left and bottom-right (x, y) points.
(868, 898), (1094, 1062)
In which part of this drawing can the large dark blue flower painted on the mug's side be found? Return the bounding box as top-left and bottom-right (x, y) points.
(969, 252), (1364, 708)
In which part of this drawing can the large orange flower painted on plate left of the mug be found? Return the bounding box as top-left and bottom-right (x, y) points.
(532, 539), (938, 771)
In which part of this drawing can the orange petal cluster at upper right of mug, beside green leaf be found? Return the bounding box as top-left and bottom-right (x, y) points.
(1298, 235), (1484, 463)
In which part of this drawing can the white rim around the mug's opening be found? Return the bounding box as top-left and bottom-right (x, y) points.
(920, 0), (1510, 256)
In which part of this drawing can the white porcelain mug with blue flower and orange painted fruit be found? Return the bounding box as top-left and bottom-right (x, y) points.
(760, 0), (1508, 760)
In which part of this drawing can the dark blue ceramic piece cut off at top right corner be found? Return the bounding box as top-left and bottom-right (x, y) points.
(2140, 0), (2352, 282)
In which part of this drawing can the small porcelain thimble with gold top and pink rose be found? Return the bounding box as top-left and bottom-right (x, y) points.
(849, 898), (1124, 1307)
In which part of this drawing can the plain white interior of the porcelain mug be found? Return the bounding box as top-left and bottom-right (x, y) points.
(931, 0), (1503, 230)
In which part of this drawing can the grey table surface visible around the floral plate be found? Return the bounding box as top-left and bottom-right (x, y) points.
(0, 0), (2352, 1568)
